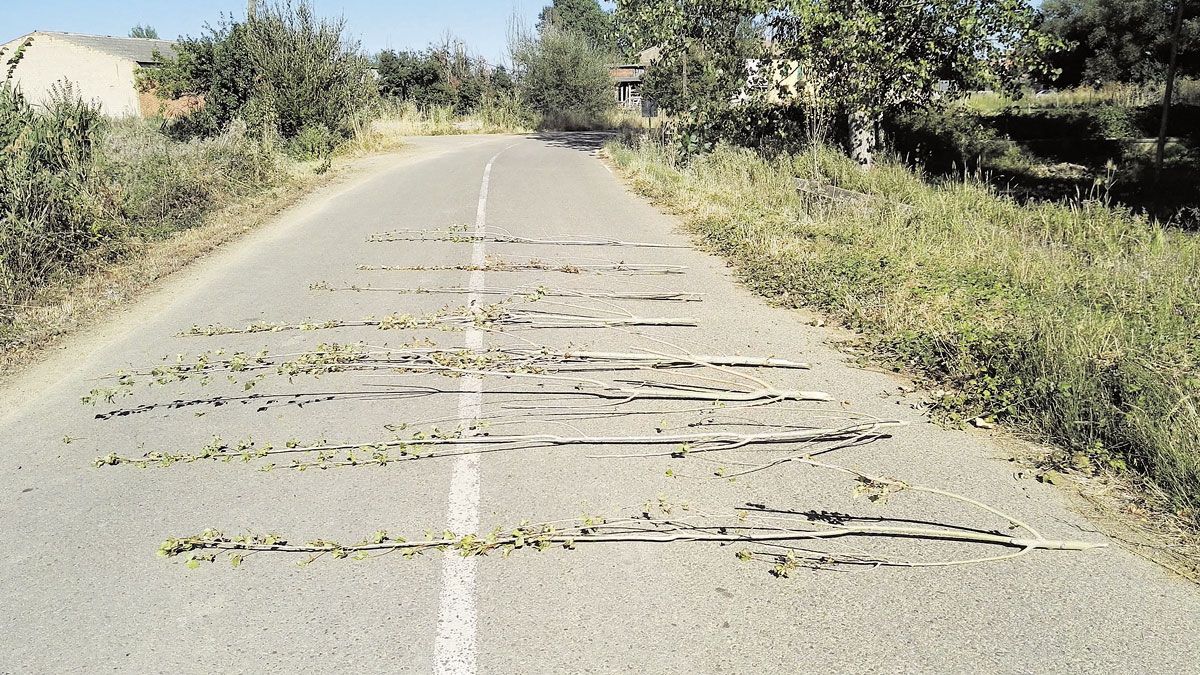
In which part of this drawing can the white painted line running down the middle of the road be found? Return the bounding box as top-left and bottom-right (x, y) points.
(433, 143), (515, 675)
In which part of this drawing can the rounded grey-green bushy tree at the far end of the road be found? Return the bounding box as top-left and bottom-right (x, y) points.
(511, 26), (616, 125)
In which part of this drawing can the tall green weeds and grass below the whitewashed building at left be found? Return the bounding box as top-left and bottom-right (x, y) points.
(0, 86), (286, 346)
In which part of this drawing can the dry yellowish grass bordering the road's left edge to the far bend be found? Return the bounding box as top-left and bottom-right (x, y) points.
(0, 95), (527, 377)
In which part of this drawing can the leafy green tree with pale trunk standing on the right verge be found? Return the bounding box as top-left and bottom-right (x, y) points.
(618, 0), (1054, 167)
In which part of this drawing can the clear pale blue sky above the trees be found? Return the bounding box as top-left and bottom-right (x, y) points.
(0, 0), (535, 62)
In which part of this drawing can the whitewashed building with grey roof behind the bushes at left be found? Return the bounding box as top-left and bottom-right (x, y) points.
(0, 31), (175, 117)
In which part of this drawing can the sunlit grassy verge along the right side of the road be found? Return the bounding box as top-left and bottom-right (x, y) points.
(608, 142), (1200, 524)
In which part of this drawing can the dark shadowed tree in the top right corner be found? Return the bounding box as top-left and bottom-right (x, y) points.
(1042, 0), (1200, 86)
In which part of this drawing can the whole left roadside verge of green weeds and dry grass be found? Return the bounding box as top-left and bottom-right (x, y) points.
(0, 105), (520, 380)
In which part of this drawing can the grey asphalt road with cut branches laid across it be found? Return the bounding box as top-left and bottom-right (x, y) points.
(0, 136), (1200, 673)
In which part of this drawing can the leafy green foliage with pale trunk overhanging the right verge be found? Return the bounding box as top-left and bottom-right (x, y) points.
(617, 0), (1055, 167)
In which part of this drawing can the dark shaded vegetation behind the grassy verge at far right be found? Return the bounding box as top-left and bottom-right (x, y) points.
(887, 80), (1200, 223)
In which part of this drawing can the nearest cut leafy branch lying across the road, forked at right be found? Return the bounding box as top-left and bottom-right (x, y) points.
(158, 459), (1106, 566)
